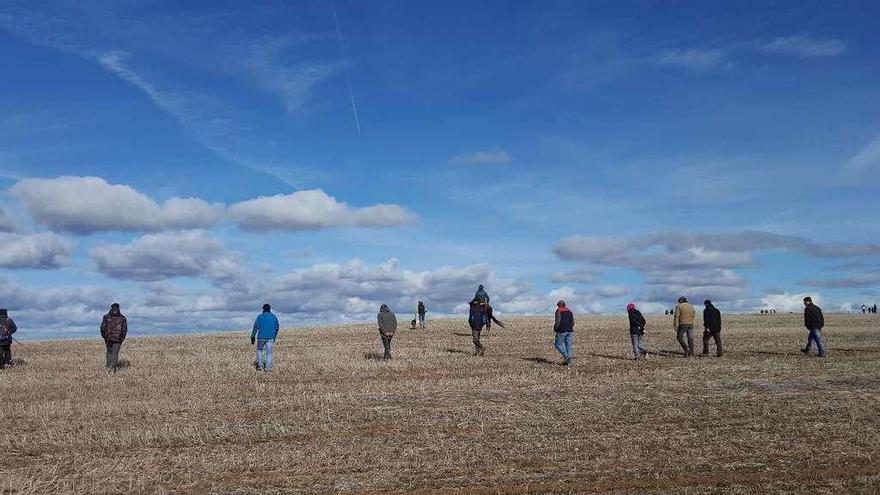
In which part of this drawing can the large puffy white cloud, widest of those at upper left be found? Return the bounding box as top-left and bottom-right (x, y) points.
(10, 176), (224, 234)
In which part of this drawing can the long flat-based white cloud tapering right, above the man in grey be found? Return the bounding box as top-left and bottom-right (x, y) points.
(229, 189), (418, 231)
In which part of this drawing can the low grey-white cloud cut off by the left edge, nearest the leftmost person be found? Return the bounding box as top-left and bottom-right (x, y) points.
(0, 232), (73, 269)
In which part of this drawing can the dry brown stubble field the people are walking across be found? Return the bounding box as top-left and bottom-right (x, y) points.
(0, 315), (880, 494)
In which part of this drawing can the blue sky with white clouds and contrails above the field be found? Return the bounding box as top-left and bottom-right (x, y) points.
(0, 0), (880, 338)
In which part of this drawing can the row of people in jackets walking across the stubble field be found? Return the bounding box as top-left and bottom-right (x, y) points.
(0, 285), (828, 374)
